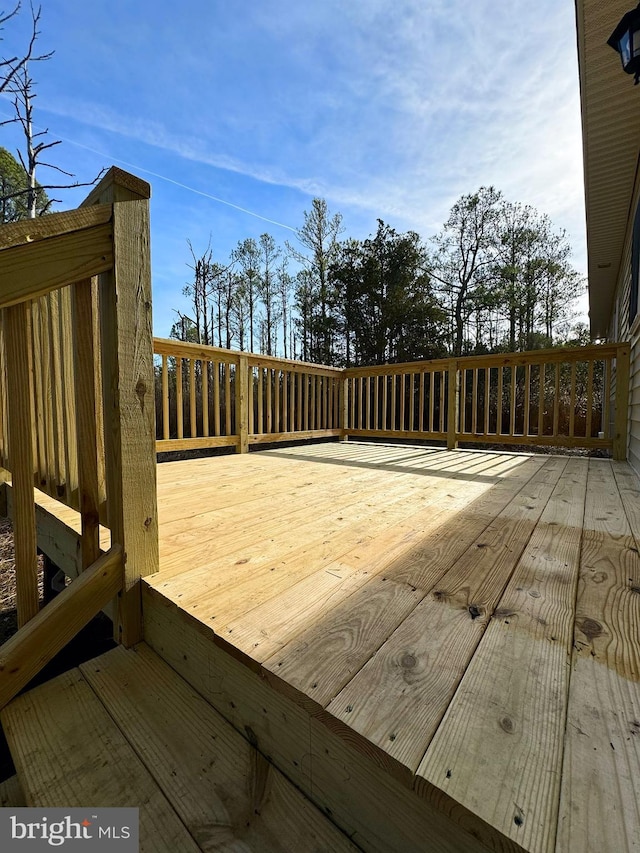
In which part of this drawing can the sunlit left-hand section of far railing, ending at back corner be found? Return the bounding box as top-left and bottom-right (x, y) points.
(154, 338), (342, 452)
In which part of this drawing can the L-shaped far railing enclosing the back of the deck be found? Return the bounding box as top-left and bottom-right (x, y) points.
(155, 339), (629, 458)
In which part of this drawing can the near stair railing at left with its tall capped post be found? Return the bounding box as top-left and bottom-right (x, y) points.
(0, 169), (158, 701)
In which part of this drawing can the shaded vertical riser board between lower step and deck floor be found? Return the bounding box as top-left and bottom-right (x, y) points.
(145, 584), (497, 853)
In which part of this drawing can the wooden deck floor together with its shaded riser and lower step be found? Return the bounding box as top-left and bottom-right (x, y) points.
(3, 443), (640, 853)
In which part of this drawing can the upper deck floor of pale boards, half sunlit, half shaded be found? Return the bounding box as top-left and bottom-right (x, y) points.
(147, 443), (640, 851)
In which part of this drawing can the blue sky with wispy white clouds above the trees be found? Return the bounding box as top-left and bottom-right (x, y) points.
(0, 0), (586, 336)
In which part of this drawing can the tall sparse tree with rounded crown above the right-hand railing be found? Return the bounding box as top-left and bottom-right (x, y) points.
(432, 187), (584, 355)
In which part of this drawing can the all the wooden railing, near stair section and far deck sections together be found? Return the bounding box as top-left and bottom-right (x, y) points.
(0, 169), (629, 705)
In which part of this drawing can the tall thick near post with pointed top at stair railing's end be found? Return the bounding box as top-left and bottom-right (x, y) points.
(85, 168), (159, 646)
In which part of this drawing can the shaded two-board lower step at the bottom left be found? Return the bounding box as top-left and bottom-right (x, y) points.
(1, 643), (360, 853)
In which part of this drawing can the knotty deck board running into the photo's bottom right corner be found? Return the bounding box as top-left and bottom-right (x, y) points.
(556, 460), (640, 853)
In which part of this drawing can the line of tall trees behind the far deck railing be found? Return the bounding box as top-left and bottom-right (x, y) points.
(171, 187), (587, 367)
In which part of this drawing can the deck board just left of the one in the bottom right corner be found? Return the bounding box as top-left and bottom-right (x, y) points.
(416, 460), (587, 851)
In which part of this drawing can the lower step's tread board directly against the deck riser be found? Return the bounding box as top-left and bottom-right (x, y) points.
(80, 644), (356, 853)
